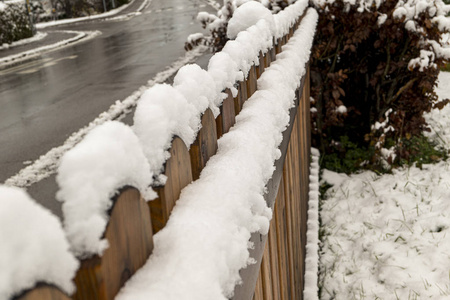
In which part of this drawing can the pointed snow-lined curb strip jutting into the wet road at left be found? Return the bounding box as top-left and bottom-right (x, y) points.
(0, 30), (101, 68)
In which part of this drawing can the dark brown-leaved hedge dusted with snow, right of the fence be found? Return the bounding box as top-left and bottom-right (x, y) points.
(311, 0), (450, 169)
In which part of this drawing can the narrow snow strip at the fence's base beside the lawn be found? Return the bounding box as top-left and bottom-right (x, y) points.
(303, 148), (320, 300)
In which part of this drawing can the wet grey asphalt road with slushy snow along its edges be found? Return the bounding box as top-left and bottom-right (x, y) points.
(0, 0), (214, 215)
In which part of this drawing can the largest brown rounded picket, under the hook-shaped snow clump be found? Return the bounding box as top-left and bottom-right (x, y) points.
(73, 187), (153, 300)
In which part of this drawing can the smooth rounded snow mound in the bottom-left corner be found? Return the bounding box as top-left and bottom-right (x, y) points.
(0, 185), (78, 299)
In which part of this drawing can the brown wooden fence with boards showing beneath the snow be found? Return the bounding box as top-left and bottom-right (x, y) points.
(17, 10), (310, 300)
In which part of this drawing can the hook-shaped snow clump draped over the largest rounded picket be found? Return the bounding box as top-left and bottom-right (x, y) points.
(56, 121), (155, 258)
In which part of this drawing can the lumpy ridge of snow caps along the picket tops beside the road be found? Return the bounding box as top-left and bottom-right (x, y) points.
(57, 0), (308, 257)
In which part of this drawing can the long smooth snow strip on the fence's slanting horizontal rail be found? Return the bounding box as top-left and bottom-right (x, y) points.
(117, 9), (318, 300)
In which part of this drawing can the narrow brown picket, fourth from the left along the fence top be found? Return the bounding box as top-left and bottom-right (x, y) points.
(189, 109), (217, 180)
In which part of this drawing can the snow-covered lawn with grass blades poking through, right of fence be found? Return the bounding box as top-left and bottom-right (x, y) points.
(319, 72), (450, 300)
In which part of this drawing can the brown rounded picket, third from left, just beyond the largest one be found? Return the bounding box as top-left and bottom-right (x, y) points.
(148, 137), (192, 233)
